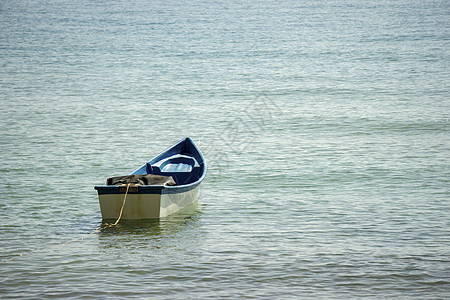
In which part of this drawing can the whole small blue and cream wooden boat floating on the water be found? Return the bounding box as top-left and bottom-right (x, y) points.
(95, 137), (206, 220)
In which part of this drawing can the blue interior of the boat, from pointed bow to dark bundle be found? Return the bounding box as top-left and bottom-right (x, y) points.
(131, 139), (205, 185)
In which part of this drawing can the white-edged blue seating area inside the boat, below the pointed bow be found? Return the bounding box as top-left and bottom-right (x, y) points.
(147, 154), (200, 185)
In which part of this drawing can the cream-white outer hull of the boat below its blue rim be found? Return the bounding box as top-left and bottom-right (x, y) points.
(99, 186), (200, 220)
